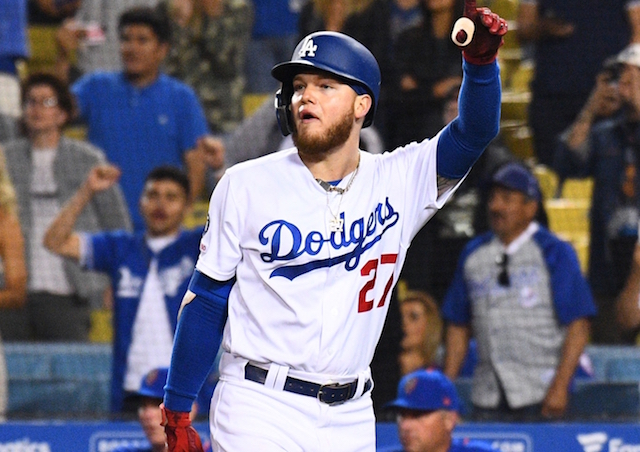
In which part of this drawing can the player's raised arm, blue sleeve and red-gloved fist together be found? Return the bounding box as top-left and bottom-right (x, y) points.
(437, 0), (507, 187)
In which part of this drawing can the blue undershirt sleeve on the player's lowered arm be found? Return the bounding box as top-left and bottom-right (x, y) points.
(164, 270), (235, 411)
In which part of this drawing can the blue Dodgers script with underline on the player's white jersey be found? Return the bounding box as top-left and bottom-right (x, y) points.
(259, 198), (400, 280)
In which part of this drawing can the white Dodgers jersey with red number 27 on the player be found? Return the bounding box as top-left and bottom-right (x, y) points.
(196, 132), (459, 377)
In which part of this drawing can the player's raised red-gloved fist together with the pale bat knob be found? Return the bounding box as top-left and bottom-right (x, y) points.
(451, 0), (507, 64)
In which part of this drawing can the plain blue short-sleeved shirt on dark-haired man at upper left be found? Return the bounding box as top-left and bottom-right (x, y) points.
(72, 72), (209, 231)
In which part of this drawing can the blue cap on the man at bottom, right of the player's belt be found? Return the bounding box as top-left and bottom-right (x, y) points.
(386, 369), (460, 411)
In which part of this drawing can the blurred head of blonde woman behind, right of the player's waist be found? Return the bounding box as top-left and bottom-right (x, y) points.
(398, 290), (443, 375)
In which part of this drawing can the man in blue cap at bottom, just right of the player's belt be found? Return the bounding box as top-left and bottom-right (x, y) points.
(387, 369), (496, 452)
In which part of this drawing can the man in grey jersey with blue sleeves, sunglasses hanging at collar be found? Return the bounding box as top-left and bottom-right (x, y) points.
(442, 162), (596, 420)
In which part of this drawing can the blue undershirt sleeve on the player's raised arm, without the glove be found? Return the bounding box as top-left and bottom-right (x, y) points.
(436, 61), (501, 179)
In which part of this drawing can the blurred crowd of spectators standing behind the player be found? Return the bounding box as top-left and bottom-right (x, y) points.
(0, 0), (640, 428)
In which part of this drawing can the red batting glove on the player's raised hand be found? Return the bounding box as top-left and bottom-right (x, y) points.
(454, 0), (507, 64)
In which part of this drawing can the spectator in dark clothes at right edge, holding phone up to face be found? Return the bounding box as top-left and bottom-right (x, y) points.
(558, 44), (640, 343)
